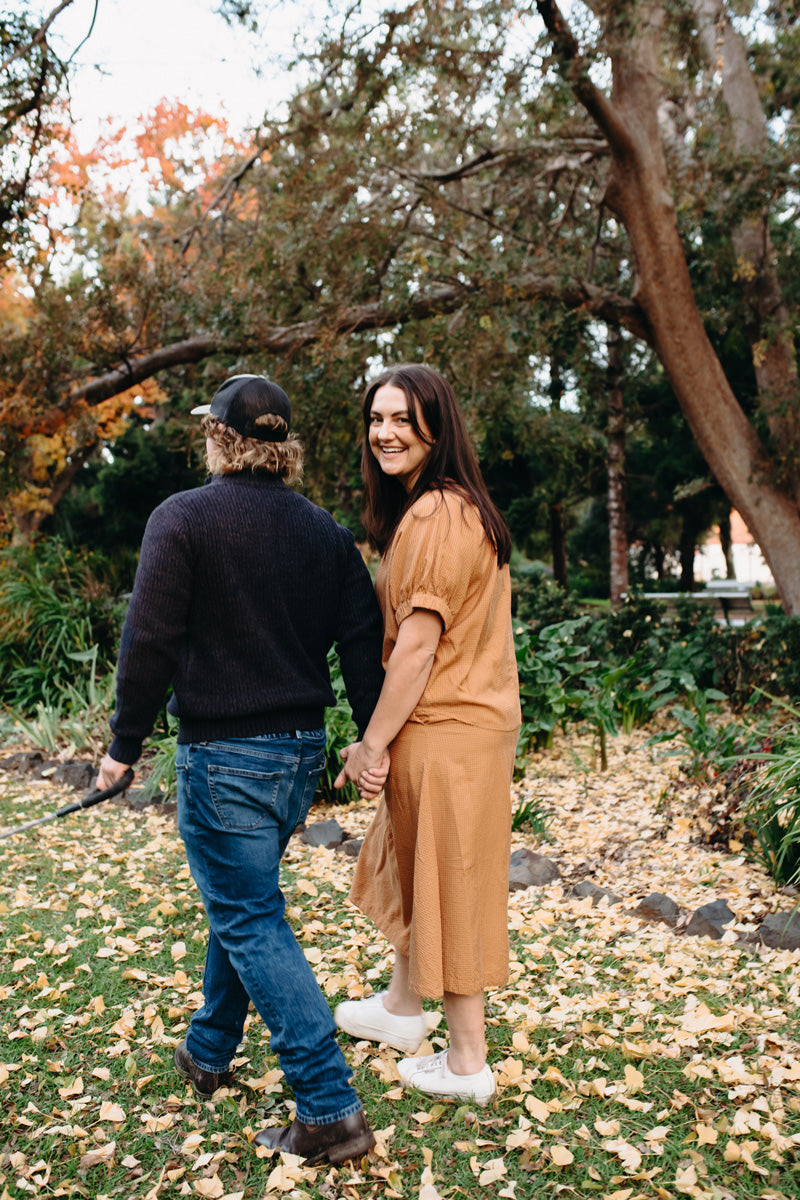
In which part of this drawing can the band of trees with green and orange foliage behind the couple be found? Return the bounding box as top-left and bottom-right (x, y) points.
(0, 0), (800, 604)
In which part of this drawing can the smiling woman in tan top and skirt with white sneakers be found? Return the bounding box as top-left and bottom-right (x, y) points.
(335, 365), (521, 1104)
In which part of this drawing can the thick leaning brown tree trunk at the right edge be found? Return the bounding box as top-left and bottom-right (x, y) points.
(536, 0), (800, 614)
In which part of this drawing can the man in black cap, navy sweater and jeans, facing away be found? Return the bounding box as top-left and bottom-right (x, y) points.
(97, 374), (383, 1163)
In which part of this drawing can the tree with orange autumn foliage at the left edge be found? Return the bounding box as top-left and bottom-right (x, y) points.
(0, 96), (251, 538)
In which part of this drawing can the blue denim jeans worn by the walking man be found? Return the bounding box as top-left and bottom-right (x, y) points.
(176, 730), (361, 1124)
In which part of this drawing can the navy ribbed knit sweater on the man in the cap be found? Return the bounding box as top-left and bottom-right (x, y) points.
(109, 472), (384, 763)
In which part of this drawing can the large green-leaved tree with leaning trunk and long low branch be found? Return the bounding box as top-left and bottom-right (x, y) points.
(4, 0), (800, 612)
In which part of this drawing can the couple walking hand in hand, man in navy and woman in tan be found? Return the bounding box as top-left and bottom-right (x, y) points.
(98, 365), (519, 1163)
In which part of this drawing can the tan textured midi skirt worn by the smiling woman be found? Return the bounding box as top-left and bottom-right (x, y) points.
(350, 721), (517, 997)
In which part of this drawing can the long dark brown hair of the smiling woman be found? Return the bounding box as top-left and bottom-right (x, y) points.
(361, 362), (511, 566)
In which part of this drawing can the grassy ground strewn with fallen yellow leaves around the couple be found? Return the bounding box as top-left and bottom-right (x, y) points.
(0, 734), (800, 1200)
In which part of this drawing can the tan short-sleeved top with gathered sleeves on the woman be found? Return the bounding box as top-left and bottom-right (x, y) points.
(375, 491), (521, 730)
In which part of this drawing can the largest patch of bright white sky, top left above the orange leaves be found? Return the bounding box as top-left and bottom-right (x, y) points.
(42, 0), (311, 143)
